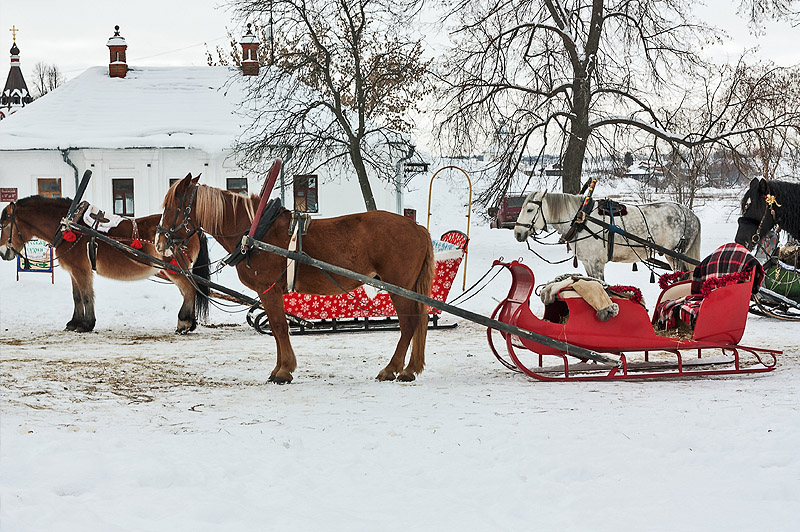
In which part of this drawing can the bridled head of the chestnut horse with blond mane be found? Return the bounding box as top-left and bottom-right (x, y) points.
(155, 174), (200, 257)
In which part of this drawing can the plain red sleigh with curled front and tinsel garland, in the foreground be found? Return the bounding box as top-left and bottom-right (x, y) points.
(487, 243), (781, 381)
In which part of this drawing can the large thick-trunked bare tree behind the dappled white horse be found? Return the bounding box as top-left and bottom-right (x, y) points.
(440, 0), (800, 203)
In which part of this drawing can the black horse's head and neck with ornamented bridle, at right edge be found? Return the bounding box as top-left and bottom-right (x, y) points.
(735, 178), (800, 250)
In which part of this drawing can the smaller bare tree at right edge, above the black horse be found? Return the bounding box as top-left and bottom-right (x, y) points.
(652, 57), (800, 207)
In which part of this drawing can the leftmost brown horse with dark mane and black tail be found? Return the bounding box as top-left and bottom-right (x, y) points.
(0, 196), (208, 333)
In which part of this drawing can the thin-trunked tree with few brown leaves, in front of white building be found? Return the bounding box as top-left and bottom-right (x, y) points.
(229, 0), (429, 210)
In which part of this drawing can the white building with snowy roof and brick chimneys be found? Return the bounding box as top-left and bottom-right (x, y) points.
(0, 28), (410, 217)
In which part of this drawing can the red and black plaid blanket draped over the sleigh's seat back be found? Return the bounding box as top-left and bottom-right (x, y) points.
(655, 243), (764, 329)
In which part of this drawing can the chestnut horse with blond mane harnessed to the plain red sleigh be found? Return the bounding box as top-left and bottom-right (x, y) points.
(156, 175), (435, 383)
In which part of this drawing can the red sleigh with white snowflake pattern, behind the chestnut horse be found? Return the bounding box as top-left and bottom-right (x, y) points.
(247, 231), (469, 334)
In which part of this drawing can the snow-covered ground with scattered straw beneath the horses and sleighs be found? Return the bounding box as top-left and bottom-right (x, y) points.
(0, 181), (800, 532)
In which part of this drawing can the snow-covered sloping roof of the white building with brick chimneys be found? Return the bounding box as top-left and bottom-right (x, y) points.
(0, 66), (245, 153)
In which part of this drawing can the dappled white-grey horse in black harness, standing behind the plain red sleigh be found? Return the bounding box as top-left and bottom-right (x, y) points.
(514, 190), (700, 279)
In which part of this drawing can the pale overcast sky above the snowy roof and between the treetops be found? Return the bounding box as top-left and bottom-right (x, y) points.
(0, 0), (800, 84)
